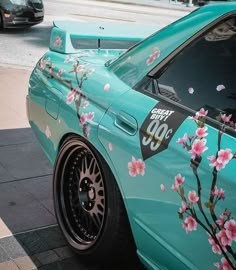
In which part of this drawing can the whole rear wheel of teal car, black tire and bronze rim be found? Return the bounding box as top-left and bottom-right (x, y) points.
(53, 137), (136, 264)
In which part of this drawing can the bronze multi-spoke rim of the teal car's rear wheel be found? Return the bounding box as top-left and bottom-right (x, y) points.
(59, 144), (105, 247)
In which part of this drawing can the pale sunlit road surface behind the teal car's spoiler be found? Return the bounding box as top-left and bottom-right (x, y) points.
(0, 0), (189, 68)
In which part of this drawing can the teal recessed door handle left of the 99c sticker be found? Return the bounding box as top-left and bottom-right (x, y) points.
(114, 111), (138, 136)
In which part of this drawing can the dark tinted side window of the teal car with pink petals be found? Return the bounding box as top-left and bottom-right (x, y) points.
(156, 18), (236, 125)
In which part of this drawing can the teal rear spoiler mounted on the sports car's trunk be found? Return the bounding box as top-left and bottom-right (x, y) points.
(49, 21), (161, 53)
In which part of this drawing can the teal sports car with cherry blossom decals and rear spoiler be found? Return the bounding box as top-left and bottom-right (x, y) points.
(27, 2), (236, 270)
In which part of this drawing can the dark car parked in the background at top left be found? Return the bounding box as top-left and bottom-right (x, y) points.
(0, 0), (44, 29)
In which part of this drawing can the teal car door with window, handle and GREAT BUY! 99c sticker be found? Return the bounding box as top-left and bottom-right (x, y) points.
(99, 17), (236, 269)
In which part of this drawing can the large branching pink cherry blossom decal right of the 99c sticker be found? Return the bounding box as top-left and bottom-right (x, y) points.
(171, 108), (236, 270)
